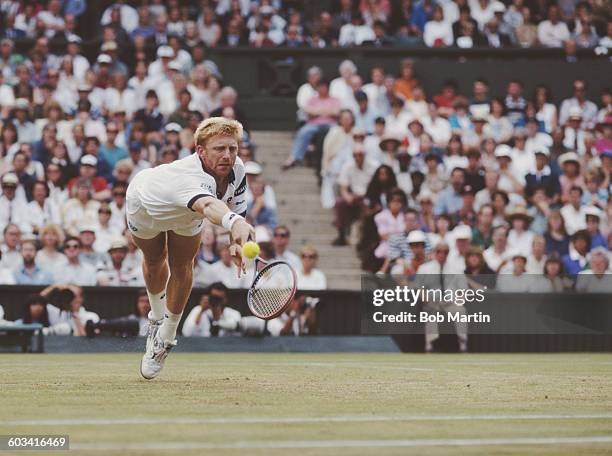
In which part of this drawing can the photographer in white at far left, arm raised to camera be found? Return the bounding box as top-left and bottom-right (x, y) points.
(40, 285), (100, 336)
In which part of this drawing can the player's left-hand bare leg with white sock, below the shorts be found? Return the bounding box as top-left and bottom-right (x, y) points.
(132, 232), (169, 320)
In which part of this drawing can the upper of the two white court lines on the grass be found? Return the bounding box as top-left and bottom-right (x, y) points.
(0, 413), (612, 426)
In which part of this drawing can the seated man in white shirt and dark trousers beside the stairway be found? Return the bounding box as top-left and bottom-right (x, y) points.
(333, 145), (376, 245)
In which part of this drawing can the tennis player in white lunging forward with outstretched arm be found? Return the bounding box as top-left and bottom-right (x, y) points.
(127, 117), (255, 379)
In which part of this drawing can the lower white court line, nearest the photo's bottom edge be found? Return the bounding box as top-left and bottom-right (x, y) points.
(70, 435), (612, 451)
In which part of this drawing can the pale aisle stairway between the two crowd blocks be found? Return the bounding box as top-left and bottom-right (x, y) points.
(253, 131), (361, 289)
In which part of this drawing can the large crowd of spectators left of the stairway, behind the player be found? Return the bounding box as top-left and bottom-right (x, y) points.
(0, 0), (326, 289)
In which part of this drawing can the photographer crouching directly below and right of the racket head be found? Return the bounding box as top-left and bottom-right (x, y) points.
(267, 293), (319, 336)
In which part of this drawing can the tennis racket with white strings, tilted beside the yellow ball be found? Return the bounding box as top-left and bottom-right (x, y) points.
(247, 257), (297, 320)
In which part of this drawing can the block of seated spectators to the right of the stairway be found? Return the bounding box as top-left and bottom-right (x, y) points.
(284, 60), (612, 291)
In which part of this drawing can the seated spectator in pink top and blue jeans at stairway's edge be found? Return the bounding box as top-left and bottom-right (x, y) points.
(283, 80), (340, 169)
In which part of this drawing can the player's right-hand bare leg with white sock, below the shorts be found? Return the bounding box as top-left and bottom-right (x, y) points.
(159, 231), (201, 342)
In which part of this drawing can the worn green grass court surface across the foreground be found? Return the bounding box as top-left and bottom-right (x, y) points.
(0, 353), (612, 455)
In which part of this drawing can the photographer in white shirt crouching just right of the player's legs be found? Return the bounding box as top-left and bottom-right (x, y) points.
(183, 282), (242, 337)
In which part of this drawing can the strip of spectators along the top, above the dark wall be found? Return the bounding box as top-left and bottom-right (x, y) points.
(0, 0), (612, 51)
